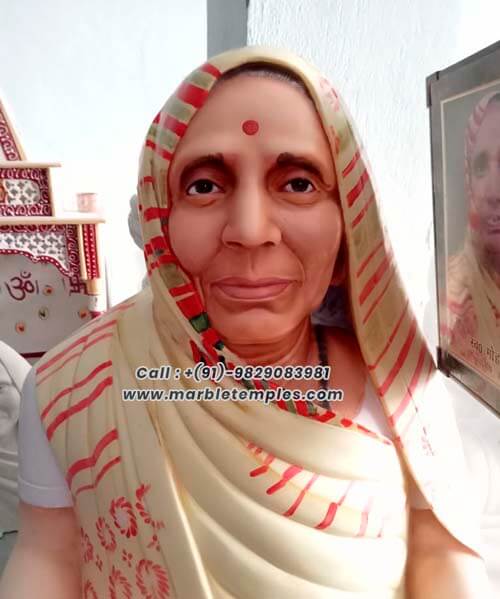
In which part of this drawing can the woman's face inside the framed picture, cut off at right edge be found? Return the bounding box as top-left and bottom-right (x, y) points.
(471, 102), (500, 254)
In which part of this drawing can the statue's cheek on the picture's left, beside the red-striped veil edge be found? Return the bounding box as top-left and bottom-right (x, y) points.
(168, 206), (220, 275)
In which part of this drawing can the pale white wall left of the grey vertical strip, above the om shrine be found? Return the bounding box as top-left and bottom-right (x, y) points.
(0, 0), (206, 304)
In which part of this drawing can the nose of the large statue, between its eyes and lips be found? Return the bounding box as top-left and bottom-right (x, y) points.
(222, 182), (281, 249)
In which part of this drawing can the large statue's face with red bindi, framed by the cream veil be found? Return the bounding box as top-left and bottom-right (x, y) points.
(168, 75), (342, 344)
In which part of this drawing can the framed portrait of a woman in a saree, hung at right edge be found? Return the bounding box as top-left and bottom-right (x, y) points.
(427, 42), (500, 416)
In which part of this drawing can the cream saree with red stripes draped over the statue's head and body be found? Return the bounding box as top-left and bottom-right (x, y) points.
(37, 48), (476, 599)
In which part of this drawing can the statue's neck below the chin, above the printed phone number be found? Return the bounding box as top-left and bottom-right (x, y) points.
(223, 318), (316, 366)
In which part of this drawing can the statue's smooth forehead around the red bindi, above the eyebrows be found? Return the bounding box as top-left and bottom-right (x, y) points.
(172, 75), (333, 169)
